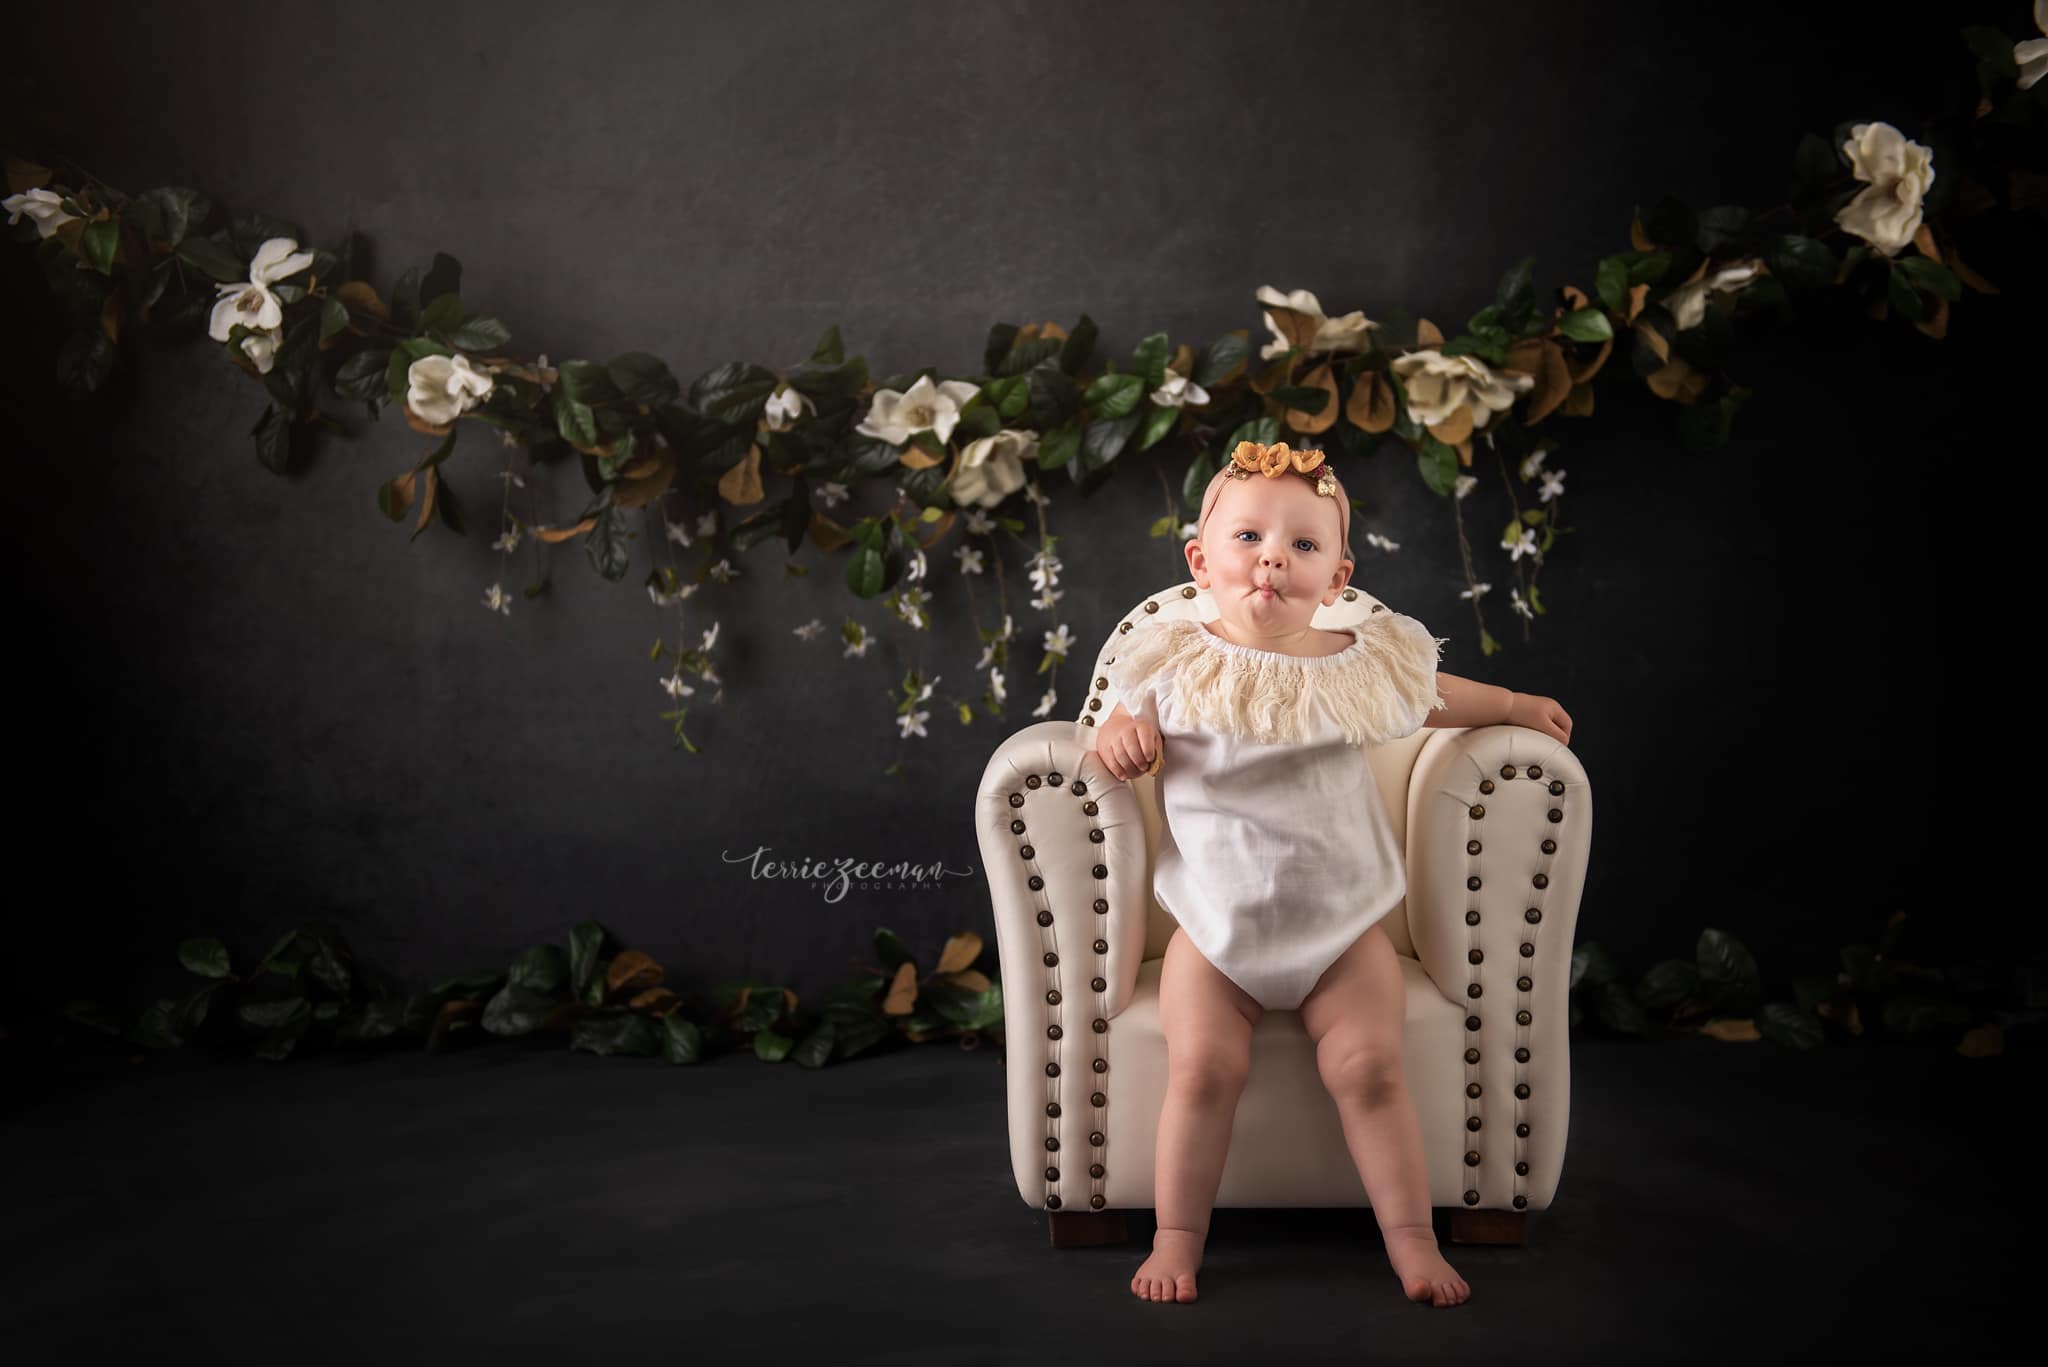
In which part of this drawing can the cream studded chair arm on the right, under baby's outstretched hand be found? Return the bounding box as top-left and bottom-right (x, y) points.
(1407, 726), (1593, 1209)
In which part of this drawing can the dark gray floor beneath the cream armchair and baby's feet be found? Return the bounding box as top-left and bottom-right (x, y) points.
(0, 1039), (2042, 1367)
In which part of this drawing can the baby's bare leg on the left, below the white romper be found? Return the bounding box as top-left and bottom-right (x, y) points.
(1130, 928), (1264, 1301)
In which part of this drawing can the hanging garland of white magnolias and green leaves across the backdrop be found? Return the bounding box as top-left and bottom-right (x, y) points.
(4, 10), (2048, 758)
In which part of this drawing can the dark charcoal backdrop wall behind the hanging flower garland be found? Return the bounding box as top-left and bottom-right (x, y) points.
(0, 0), (2025, 1024)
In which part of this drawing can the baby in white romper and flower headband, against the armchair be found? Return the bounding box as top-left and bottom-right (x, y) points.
(1096, 441), (1571, 1306)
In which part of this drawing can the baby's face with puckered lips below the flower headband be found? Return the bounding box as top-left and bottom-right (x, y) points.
(1188, 475), (1352, 635)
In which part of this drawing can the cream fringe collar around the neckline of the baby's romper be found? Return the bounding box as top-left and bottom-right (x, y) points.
(1114, 611), (1450, 746)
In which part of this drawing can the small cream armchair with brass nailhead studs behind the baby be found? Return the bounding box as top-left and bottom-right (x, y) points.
(975, 582), (1593, 1246)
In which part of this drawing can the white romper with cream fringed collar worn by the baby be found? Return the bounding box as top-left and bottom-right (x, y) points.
(1104, 611), (1448, 1010)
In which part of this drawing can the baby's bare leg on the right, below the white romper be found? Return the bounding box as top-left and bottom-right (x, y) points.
(1300, 926), (1473, 1306)
